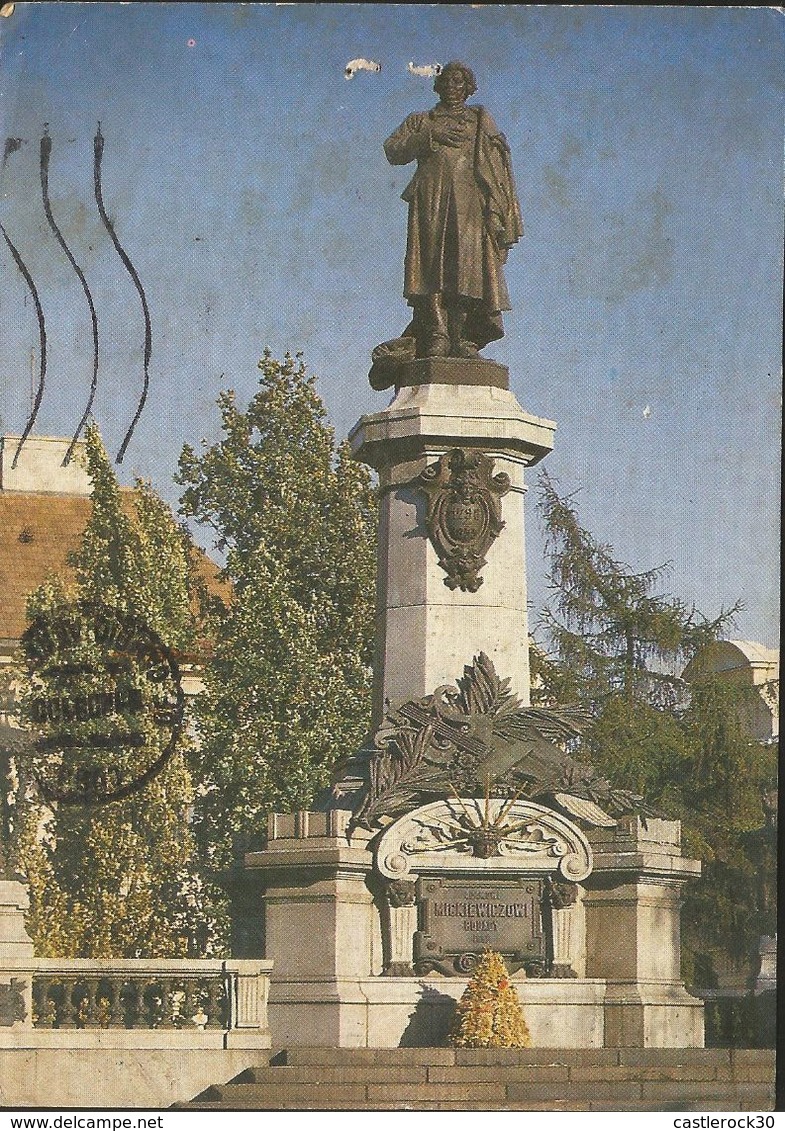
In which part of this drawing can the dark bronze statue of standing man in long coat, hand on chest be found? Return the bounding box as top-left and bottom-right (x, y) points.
(385, 62), (524, 357)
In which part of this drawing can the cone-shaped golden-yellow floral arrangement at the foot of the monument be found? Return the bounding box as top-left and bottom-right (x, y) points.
(448, 950), (532, 1048)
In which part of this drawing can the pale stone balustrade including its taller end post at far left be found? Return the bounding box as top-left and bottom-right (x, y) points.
(0, 880), (273, 1076)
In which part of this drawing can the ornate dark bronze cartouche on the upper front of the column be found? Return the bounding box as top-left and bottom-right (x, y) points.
(415, 448), (510, 593)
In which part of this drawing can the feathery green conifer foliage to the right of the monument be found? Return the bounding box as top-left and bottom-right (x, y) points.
(532, 475), (776, 987)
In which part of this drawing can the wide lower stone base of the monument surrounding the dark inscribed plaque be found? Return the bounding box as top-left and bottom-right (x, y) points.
(245, 802), (704, 1048)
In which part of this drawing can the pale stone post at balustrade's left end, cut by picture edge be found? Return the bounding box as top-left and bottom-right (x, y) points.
(0, 879), (34, 1029)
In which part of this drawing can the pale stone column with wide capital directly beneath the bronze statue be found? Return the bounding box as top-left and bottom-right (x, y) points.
(350, 359), (555, 723)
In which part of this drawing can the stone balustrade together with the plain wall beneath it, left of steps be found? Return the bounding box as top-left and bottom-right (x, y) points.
(0, 952), (273, 1107)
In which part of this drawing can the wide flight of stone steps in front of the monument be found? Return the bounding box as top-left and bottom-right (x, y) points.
(178, 1047), (775, 1112)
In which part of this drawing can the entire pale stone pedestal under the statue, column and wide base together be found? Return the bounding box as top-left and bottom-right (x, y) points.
(240, 359), (702, 1047)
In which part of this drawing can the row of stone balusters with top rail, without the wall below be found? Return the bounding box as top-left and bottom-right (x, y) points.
(33, 959), (271, 1031)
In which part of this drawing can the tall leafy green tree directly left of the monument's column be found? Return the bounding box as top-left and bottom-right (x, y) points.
(178, 351), (377, 867)
